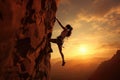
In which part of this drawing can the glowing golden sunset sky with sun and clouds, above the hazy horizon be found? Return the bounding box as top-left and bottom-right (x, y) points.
(52, 0), (120, 59)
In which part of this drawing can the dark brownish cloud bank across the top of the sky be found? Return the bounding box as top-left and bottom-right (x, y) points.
(58, 0), (120, 19)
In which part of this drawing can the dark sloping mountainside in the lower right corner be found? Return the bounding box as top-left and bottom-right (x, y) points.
(89, 50), (120, 80)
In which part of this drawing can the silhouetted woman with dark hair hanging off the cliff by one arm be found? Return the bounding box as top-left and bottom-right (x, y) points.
(50, 18), (73, 66)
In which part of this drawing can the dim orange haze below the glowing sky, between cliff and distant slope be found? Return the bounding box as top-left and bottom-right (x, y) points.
(51, 54), (108, 80)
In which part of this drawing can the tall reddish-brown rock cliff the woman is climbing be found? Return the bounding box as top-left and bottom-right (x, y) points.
(0, 0), (57, 80)
